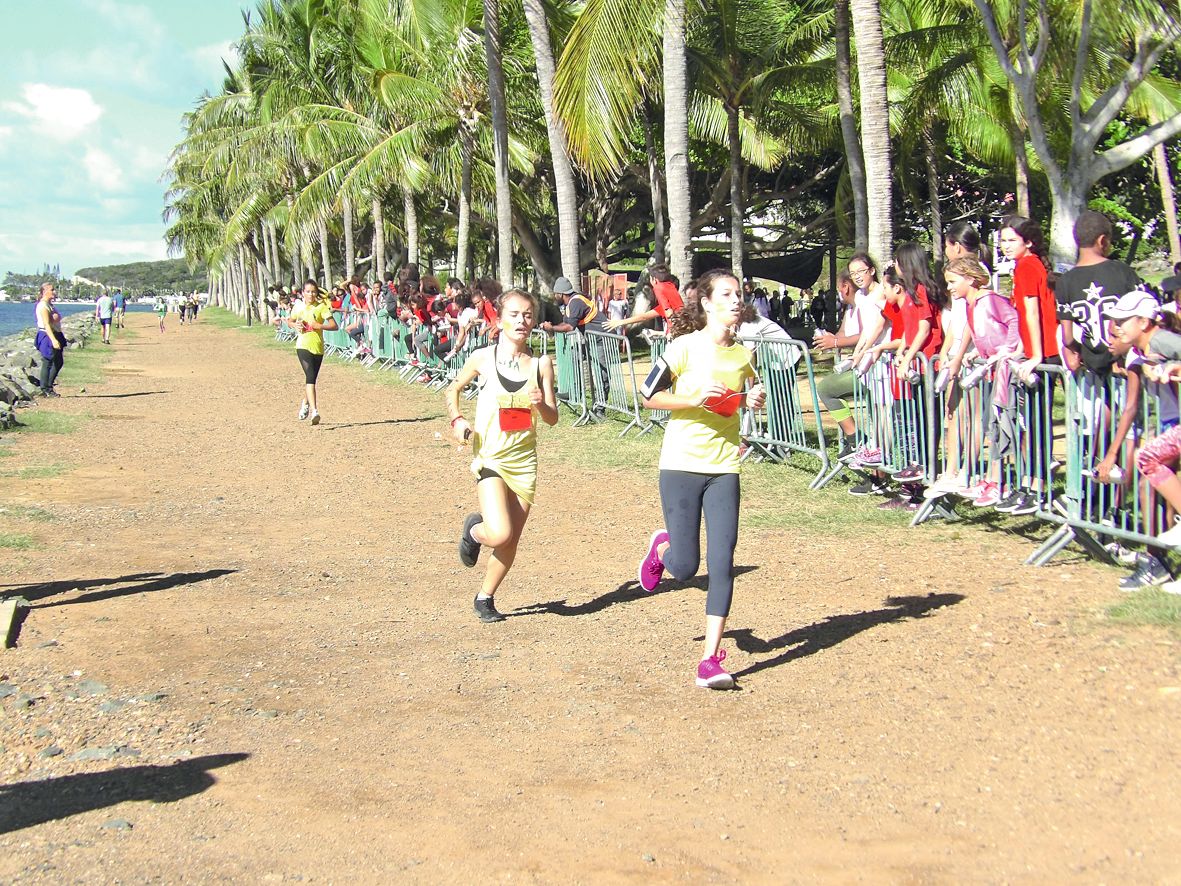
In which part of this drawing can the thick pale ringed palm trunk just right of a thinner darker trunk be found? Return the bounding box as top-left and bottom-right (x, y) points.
(849, 0), (894, 265)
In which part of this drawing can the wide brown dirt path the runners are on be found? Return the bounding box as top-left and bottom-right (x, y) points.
(0, 315), (1181, 884)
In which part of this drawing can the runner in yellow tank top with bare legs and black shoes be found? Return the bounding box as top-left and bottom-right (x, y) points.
(444, 289), (557, 623)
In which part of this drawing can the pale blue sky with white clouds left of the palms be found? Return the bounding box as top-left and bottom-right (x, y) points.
(0, 0), (253, 279)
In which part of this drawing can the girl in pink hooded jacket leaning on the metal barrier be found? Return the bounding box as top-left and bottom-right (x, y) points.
(934, 258), (1023, 508)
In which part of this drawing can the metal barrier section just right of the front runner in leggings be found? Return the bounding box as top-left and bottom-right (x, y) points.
(742, 338), (829, 489)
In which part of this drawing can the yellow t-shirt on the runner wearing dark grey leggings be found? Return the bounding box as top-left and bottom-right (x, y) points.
(660, 330), (755, 474)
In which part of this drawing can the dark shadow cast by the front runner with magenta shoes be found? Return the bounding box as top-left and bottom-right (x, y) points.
(722, 594), (964, 677)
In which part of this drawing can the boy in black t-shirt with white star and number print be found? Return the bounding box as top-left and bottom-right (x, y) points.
(1055, 209), (1141, 379)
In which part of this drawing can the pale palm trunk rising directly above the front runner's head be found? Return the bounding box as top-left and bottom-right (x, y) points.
(664, 0), (693, 284)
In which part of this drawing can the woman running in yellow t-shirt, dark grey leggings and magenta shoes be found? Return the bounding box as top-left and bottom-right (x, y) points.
(639, 271), (765, 689)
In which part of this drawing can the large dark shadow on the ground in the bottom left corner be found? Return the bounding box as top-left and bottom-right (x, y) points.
(0, 754), (250, 834)
